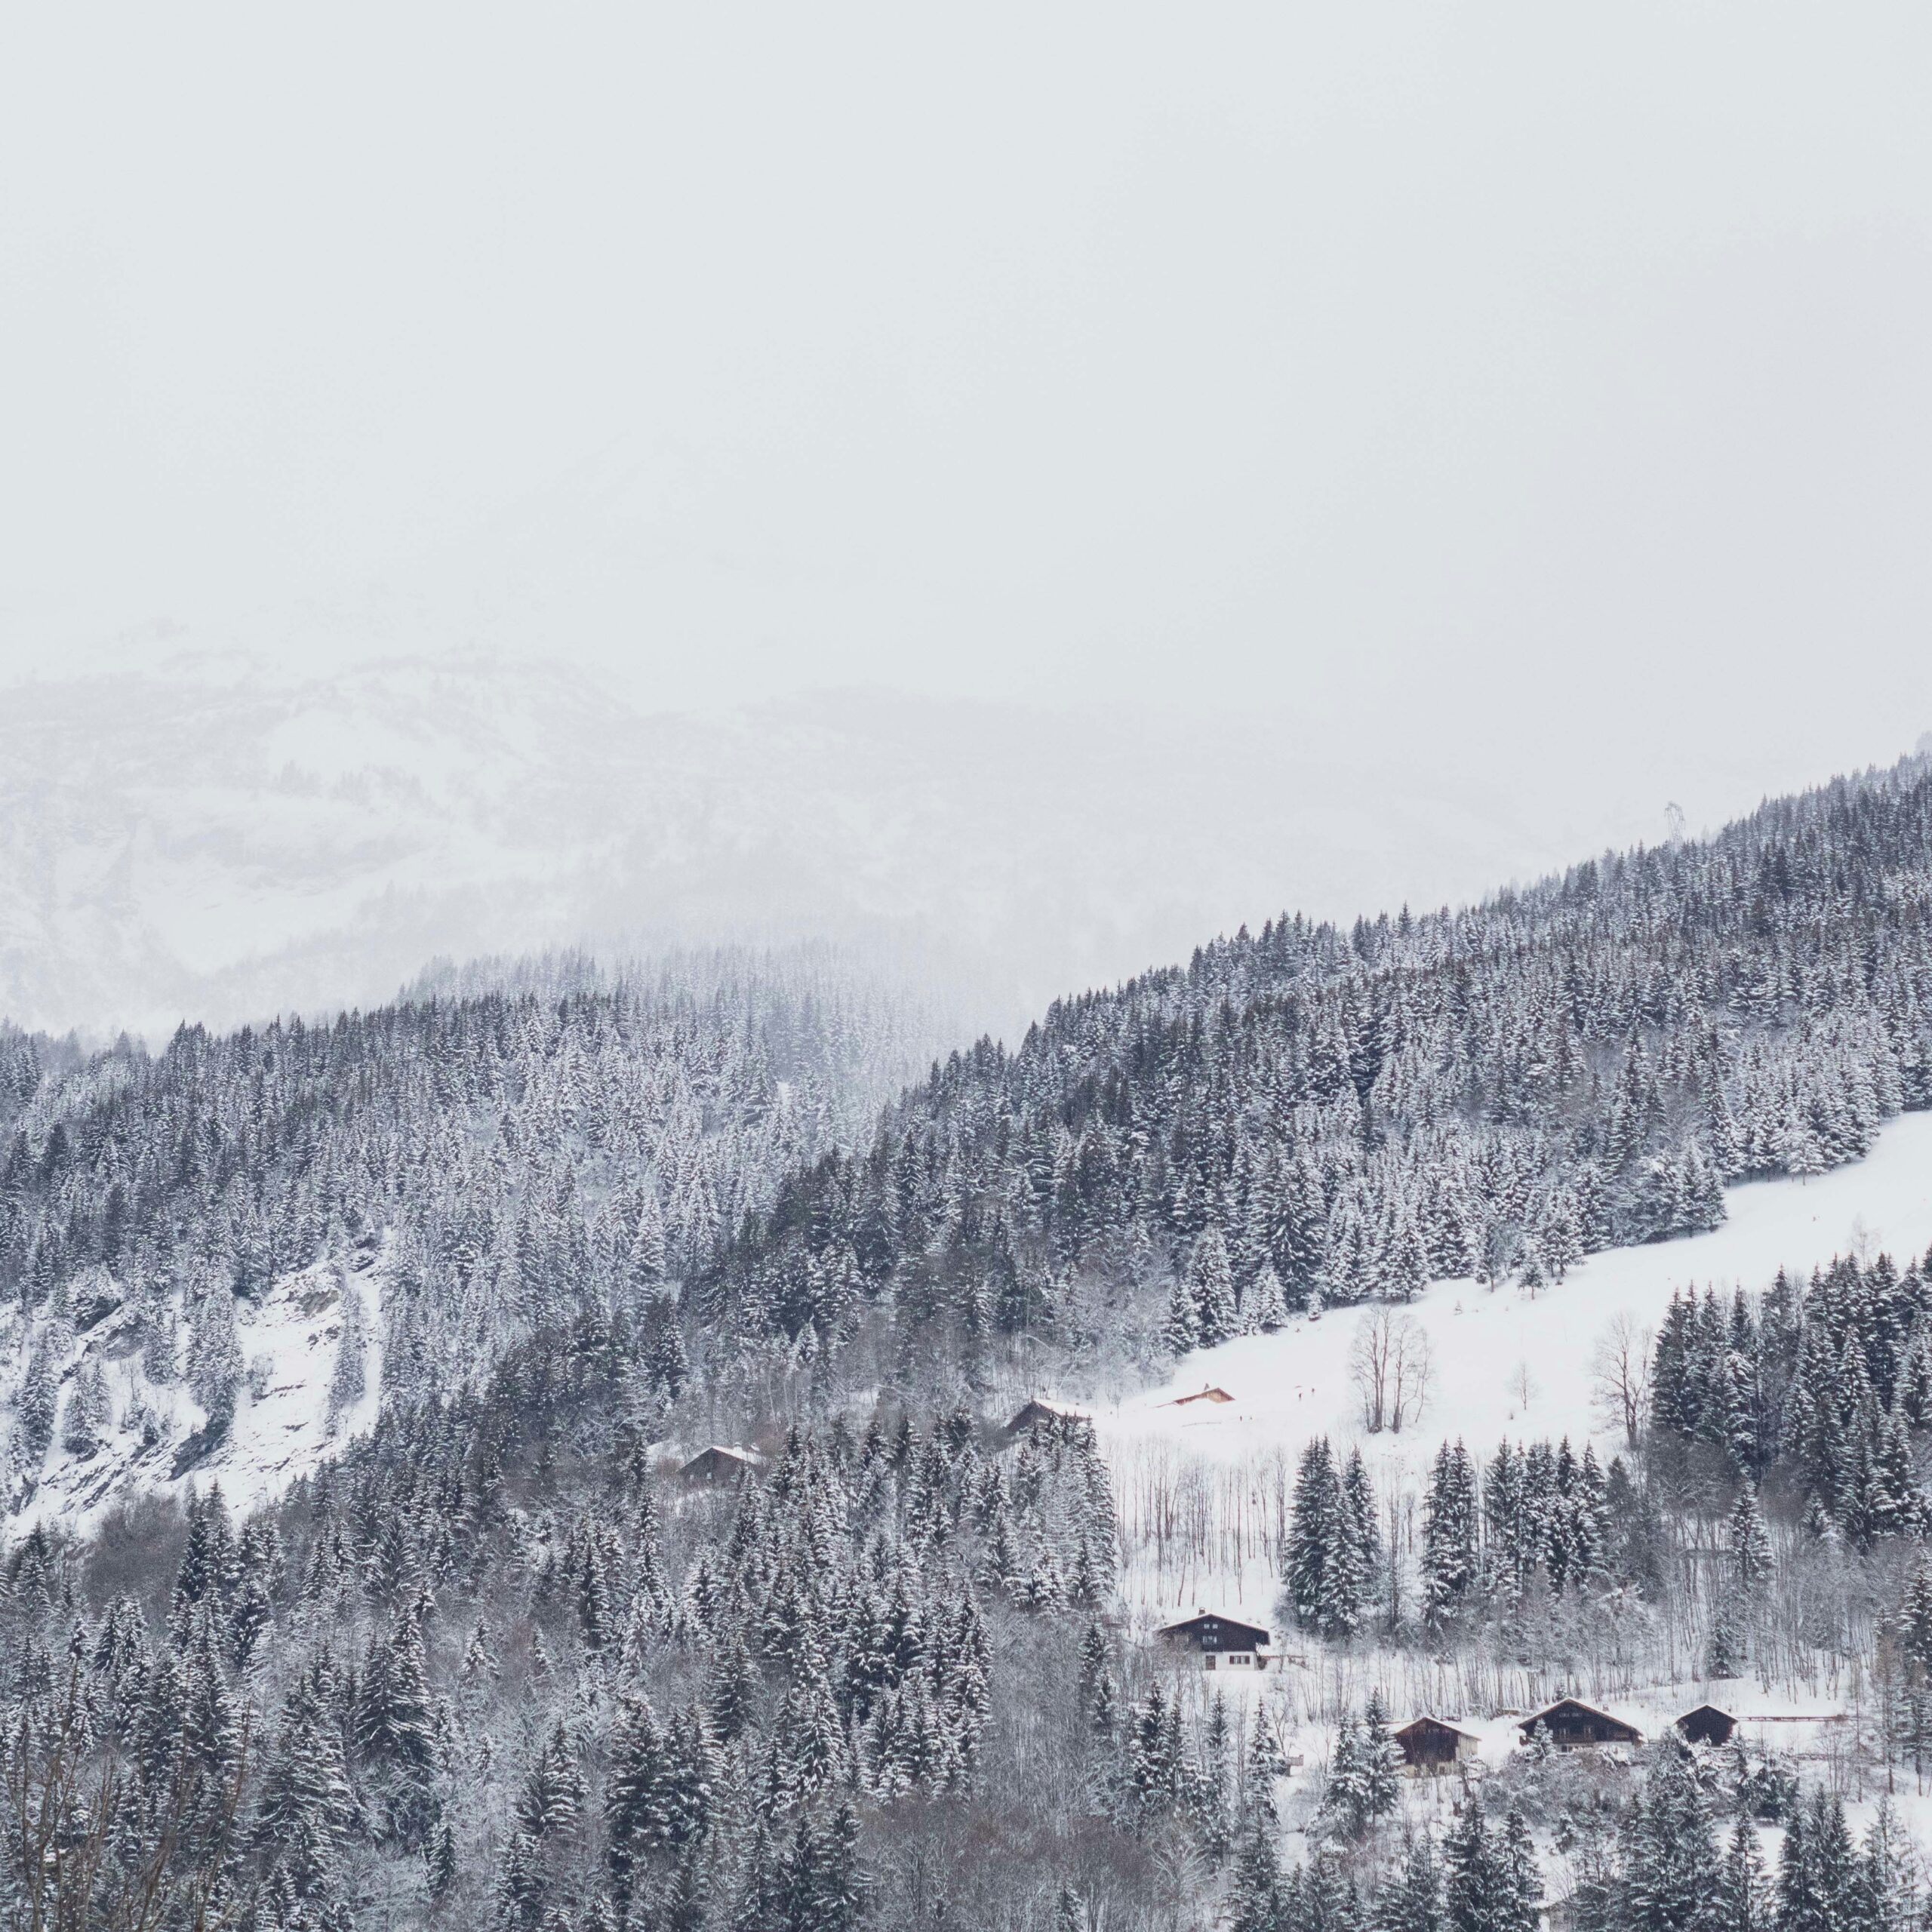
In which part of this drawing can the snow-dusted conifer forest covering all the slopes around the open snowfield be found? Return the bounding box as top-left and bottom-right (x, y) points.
(0, 759), (1932, 1932)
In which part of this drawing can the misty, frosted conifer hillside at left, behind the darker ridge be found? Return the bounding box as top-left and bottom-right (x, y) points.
(0, 952), (935, 1507)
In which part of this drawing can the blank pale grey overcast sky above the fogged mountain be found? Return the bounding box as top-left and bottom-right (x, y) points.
(0, 0), (1932, 830)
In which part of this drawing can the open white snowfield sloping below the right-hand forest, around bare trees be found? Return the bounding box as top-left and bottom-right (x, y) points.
(1082, 1113), (1932, 1623)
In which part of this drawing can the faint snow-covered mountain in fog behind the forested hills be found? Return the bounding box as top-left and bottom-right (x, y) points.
(0, 653), (1662, 1035)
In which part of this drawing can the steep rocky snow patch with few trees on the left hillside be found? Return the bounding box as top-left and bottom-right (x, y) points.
(0, 1254), (389, 1536)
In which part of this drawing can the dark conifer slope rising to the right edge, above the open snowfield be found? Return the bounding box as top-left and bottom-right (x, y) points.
(707, 759), (1932, 1383)
